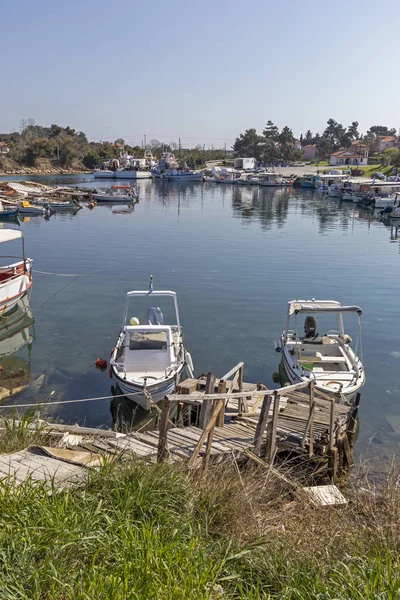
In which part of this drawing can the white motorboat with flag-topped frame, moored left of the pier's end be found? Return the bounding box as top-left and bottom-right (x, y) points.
(110, 279), (193, 410)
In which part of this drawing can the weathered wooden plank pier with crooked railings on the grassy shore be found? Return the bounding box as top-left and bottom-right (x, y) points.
(0, 363), (360, 486)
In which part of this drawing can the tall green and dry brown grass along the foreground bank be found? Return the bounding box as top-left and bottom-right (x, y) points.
(0, 429), (400, 600)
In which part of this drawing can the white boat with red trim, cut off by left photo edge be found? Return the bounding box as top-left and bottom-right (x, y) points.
(0, 229), (32, 316)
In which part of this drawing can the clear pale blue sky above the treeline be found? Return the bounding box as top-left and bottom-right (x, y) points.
(0, 0), (400, 147)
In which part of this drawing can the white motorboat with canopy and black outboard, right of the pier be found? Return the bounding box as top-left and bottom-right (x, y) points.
(275, 299), (365, 402)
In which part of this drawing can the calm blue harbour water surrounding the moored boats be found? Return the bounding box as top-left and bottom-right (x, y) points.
(0, 176), (400, 464)
